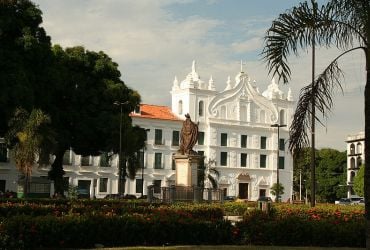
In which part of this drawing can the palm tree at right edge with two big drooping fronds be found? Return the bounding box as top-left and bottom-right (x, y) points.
(262, 0), (370, 243)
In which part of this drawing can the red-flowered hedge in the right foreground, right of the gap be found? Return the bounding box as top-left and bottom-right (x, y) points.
(236, 204), (366, 247)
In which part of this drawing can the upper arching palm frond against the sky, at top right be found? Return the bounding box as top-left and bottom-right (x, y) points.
(262, 0), (367, 83)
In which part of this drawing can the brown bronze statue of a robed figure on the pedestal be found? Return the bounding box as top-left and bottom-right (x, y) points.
(178, 114), (198, 155)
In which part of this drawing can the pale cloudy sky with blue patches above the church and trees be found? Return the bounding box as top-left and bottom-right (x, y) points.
(33, 0), (365, 151)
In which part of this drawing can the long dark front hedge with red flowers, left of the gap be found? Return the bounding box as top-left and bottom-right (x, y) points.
(0, 214), (232, 249)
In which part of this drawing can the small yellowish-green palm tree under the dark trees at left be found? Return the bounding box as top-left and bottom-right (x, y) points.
(6, 109), (53, 196)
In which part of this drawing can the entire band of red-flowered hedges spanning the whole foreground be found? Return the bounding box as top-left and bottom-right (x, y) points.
(0, 200), (365, 249)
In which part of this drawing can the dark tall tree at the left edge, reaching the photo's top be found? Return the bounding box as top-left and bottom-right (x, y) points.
(0, 0), (51, 136)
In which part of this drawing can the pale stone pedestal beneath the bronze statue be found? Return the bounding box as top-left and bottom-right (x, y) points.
(173, 154), (203, 187)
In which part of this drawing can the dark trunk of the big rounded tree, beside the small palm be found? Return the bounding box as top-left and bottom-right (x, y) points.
(49, 149), (66, 195)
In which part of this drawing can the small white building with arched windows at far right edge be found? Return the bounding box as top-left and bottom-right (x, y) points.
(346, 131), (365, 198)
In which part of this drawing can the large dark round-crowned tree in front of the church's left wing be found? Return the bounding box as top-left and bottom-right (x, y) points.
(40, 45), (144, 193)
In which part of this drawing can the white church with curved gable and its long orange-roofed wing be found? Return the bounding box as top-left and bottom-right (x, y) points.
(0, 62), (294, 201)
